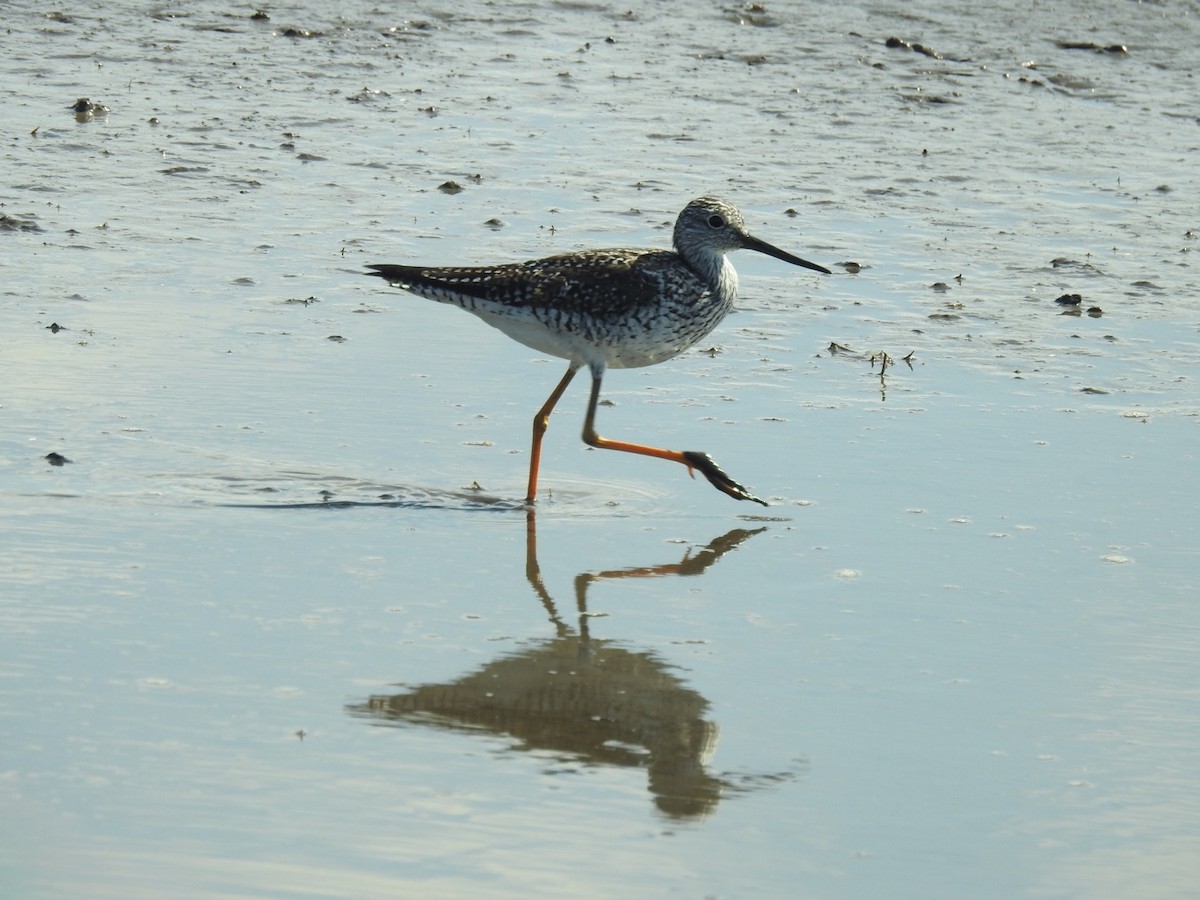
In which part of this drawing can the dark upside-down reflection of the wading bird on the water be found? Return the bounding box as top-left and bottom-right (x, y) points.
(347, 510), (779, 818)
